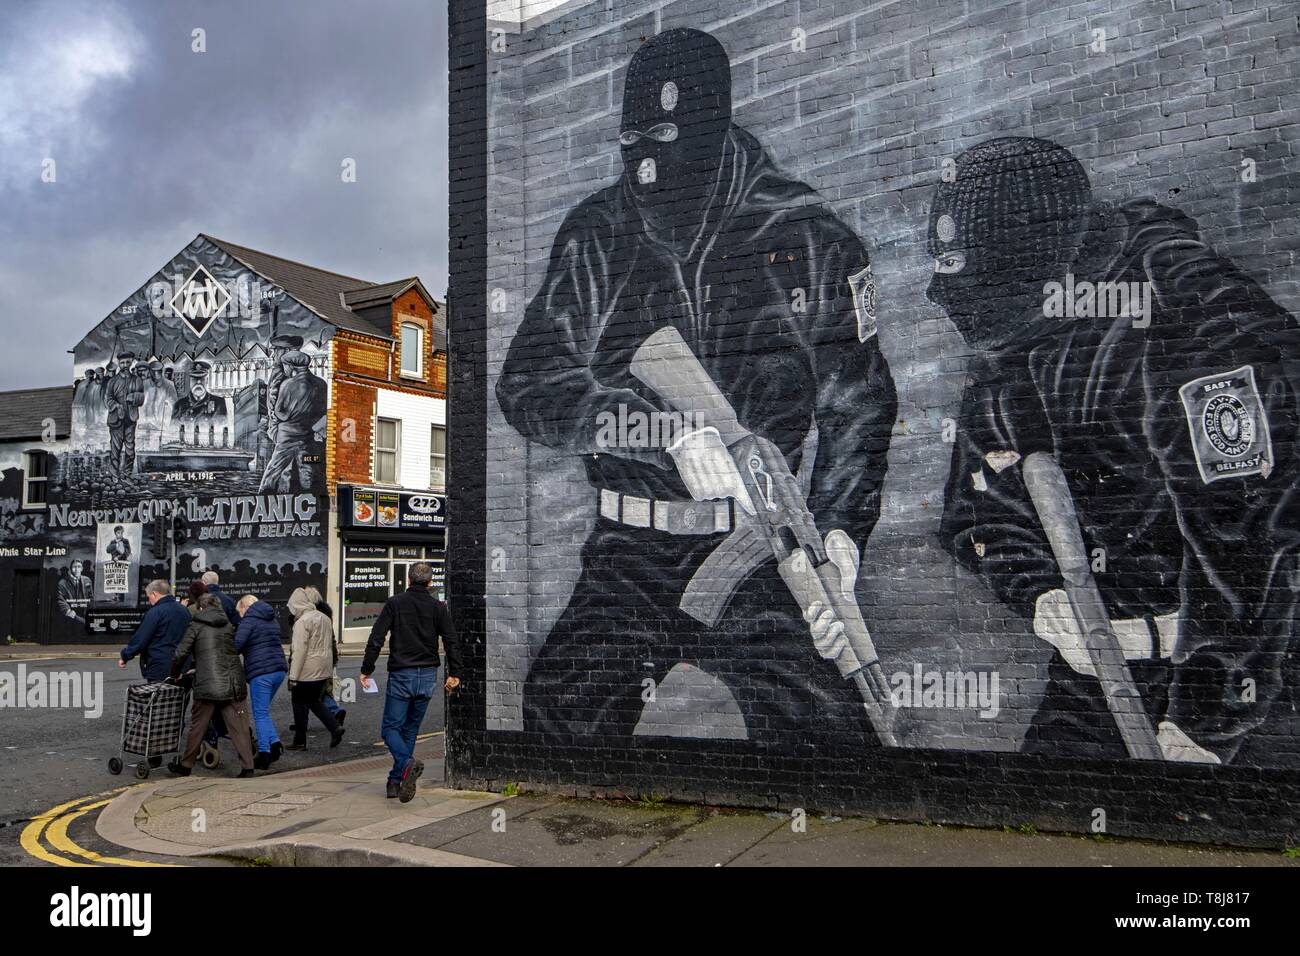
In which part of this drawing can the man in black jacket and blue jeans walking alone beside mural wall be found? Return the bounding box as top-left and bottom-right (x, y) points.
(361, 562), (460, 804)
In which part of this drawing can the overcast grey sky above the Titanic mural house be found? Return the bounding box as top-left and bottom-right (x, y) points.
(0, 0), (447, 389)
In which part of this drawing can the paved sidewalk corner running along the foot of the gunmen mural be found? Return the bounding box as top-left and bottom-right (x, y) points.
(96, 737), (1300, 866)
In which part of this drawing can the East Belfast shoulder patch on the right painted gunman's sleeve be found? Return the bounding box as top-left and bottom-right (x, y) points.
(1178, 365), (1273, 484)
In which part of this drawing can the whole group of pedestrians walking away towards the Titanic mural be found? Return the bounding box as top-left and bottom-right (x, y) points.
(118, 563), (460, 803)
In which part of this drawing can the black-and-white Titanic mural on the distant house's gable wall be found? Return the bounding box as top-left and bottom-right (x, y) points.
(0, 237), (333, 643)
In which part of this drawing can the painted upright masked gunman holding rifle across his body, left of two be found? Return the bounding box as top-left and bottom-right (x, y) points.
(497, 30), (896, 747)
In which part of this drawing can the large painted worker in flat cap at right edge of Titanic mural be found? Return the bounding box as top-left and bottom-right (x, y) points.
(254, 350), (329, 492)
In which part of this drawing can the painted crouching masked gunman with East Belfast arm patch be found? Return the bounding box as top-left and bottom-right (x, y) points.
(928, 138), (1300, 763)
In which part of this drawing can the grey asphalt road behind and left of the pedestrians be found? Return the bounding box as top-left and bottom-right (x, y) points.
(0, 657), (445, 865)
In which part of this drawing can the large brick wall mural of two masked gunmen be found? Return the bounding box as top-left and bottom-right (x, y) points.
(449, 0), (1300, 842)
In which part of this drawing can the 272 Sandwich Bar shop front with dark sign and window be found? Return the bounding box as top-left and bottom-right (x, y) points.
(337, 484), (447, 644)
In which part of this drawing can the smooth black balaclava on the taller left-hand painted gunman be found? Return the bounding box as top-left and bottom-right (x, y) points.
(619, 30), (731, 239)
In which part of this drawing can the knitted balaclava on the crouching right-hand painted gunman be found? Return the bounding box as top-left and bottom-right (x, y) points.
(927, 137), (1092, 350)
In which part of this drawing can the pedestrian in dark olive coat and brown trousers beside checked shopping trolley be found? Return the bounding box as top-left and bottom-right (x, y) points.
(168, 594), (254, 777)
